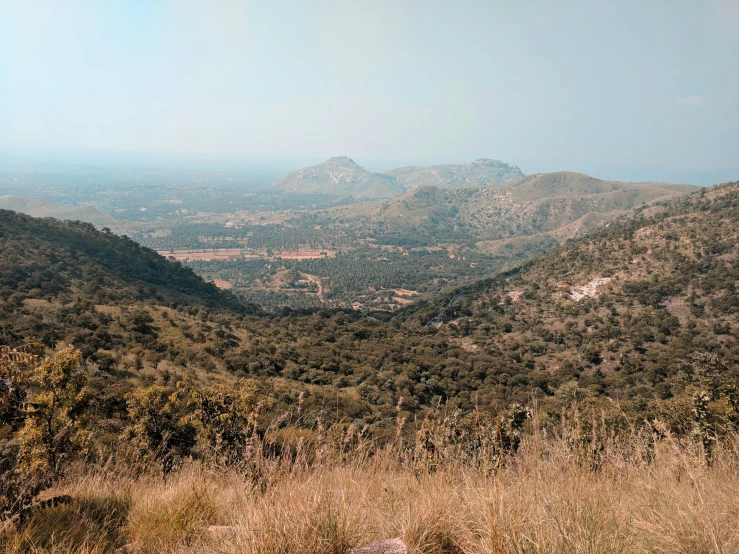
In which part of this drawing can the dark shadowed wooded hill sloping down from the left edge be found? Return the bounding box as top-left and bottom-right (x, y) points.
(0, 210), (249, 320)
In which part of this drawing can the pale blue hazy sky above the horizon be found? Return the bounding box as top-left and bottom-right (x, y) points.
(0, 0), (739, 180)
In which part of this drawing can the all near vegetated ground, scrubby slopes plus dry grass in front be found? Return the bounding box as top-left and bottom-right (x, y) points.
(0, 183), (739, 552)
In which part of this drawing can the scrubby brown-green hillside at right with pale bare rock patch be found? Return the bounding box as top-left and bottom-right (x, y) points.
(398, 183), (739, 414)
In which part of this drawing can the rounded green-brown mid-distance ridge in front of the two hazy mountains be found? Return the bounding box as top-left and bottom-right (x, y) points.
(328, 172), (697, 251)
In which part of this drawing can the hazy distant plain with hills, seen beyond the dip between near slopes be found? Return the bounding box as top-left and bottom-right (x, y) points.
(0, 161), (695, 311)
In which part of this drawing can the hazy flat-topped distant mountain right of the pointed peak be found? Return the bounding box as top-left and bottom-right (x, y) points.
(385, 158), (524, 189)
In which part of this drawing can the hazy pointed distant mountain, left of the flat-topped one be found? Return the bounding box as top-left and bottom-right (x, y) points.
(271, 156), (405, 200)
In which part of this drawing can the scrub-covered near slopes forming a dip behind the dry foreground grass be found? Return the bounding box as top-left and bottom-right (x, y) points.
(3, 184), (739, 423)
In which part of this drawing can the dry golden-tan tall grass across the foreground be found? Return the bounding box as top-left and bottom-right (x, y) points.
(0, 420), (739, 554)
